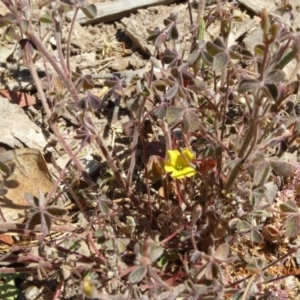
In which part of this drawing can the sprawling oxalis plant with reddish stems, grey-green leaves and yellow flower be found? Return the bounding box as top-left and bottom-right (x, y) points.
(0, 0), (300, 299)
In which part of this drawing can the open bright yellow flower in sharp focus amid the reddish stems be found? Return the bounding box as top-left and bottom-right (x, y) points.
(165, 149), (197, 179)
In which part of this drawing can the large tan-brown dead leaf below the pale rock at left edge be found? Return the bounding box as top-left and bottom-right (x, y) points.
(0, 149), (53, 223)
